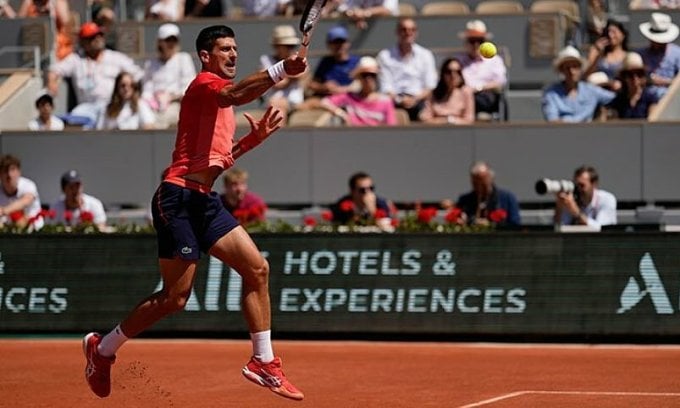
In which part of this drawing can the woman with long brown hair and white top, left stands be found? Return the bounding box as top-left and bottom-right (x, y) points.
(97, 72), (156, 130)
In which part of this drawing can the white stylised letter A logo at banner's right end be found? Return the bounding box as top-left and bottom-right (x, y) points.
(616, 252), (673, 314)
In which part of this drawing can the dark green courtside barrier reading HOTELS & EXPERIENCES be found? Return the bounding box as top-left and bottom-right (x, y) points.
(0, 232), (680, 339)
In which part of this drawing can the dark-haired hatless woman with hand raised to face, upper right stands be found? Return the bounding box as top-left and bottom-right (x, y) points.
(583, 20), (628, 91)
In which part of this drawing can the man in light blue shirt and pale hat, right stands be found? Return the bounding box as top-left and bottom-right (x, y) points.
(542, 46), (616, 122)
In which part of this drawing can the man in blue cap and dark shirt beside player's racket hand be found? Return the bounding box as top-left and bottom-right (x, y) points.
(301, 26), (359, 109)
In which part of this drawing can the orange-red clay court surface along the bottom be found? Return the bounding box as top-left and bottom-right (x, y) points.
(0, 340), (680, 408)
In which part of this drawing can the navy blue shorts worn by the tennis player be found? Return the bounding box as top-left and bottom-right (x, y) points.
(151, 182), (239, 260)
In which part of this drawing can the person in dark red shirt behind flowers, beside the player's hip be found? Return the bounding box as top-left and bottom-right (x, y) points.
(220, 167), (267, 224)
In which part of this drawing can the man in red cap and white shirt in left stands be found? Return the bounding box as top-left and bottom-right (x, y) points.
(47, 22), (143, 127)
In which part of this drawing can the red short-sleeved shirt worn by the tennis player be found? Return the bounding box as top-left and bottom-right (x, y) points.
(164, 71), (236, 187)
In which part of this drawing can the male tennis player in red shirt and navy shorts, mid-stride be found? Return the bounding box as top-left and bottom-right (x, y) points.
(83, 25), (307, 400)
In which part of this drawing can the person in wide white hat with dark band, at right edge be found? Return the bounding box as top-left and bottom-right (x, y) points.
(637, 13), (680, 98)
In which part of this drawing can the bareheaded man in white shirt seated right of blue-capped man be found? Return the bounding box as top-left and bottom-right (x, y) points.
(377, 18), (437, 121)
